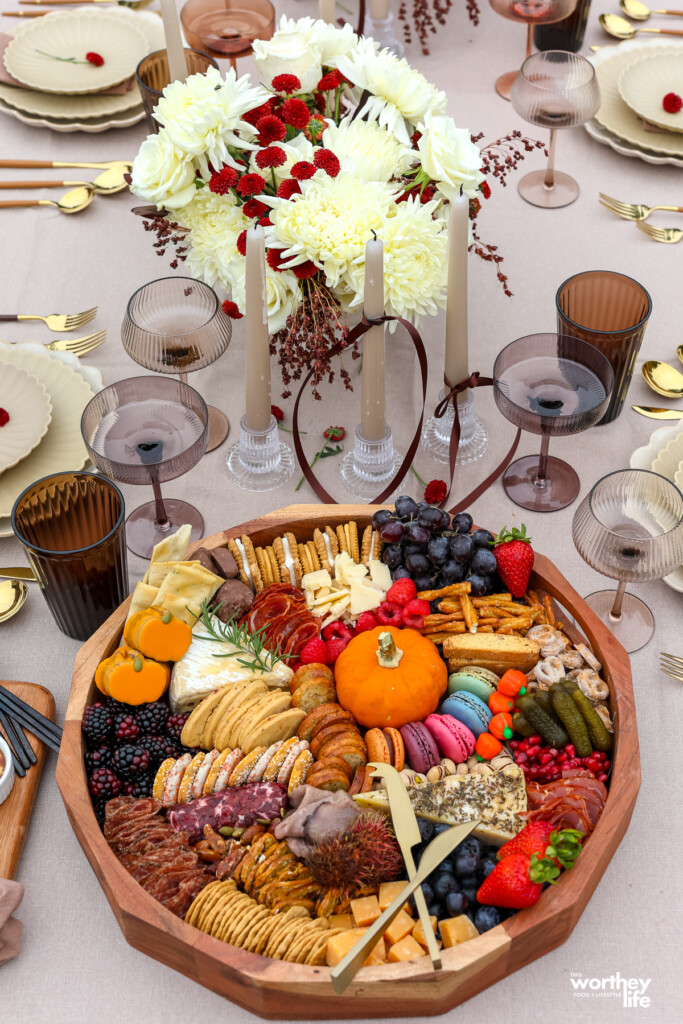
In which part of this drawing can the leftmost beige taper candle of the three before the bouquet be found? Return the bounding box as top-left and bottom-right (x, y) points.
(245, 224), (270, 430)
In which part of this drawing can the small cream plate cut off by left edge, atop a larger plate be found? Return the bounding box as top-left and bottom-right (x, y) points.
(0, 360), (52, 473)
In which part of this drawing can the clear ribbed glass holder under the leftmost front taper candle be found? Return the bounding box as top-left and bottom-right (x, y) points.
(226, 416), (294, 490)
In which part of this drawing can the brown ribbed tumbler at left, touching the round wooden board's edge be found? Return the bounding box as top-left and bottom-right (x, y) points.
(11, 473), (128, 640)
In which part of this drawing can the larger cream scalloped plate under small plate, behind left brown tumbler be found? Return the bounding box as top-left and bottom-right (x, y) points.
(0, 342), (102, 537)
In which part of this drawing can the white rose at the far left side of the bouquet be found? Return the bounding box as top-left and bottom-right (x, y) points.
(130, 131), (196, 210)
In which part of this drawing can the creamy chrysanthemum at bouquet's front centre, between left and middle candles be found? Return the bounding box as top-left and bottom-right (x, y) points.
(259, 172), (397, 288)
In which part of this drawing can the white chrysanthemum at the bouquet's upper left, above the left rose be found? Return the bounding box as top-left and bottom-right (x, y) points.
(155, 68), (269, 178)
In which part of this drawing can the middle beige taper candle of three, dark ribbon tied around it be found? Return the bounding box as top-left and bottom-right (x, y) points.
(360, 239), (386, 441)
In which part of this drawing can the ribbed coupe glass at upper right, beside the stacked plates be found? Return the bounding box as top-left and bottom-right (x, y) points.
(510, 50), (600, 209)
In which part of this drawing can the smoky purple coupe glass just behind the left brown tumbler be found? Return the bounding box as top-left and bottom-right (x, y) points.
(81, 377), (209, 558)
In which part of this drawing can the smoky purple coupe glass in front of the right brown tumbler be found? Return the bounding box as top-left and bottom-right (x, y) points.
(494, 334), (613, 512)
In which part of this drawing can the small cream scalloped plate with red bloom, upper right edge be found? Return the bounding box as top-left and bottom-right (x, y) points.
(616, 48), (683, 132)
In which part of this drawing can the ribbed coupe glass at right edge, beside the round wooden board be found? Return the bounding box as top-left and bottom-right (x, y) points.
(571, 469), (683, 653)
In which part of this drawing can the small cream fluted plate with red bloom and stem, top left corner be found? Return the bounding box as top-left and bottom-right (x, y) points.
(3, 10), (147, 93)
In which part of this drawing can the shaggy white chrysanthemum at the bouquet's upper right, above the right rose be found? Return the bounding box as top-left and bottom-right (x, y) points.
(338, 39), (445, 145)
